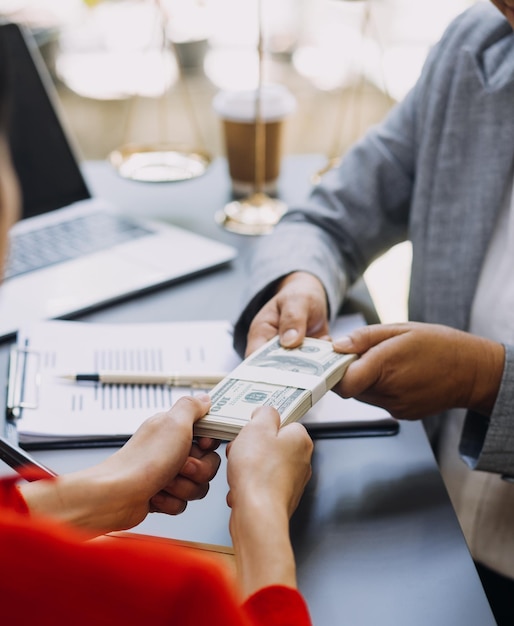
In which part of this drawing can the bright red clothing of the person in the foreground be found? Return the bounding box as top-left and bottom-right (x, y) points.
(0, 480), (311, 626)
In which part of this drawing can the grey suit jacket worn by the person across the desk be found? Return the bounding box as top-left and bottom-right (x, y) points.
(235, 3), (514, 474)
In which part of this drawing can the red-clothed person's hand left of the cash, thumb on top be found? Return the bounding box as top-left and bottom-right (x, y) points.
(22, 396), (220, 534)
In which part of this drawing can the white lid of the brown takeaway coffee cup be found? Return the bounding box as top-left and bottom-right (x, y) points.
(212, 83), (296, 122)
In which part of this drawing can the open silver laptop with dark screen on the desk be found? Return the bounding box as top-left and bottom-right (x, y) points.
(0, 22), (236, 338)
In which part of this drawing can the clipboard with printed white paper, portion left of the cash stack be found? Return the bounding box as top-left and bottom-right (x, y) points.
(6, 320), (240, 449)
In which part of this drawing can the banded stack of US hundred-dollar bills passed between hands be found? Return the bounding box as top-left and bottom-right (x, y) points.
(194, 337), (356, 441)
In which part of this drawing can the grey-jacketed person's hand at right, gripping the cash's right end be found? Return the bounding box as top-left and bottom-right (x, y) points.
(334, 322), (505, 420)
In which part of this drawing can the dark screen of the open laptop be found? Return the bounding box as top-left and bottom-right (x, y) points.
(0, 23), (91, 218)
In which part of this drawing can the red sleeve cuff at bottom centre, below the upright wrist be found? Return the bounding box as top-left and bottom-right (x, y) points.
(244, 585), (311, 626)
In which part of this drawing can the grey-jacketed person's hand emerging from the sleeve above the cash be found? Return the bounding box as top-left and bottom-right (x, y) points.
(246, 272), (329, 356)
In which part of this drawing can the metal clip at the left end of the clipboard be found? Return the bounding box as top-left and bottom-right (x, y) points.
(7, 346), (41, 419)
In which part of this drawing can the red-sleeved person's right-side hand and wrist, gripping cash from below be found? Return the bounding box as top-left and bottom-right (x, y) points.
(227, 407), (313, 595)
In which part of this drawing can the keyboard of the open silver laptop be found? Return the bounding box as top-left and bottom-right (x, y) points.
(5, 213), (152, 278)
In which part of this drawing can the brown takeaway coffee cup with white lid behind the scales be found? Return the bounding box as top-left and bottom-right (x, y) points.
(213, 84), (296, 197)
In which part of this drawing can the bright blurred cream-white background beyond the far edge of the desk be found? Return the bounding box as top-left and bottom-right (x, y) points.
(0, 0), (485, 159)
